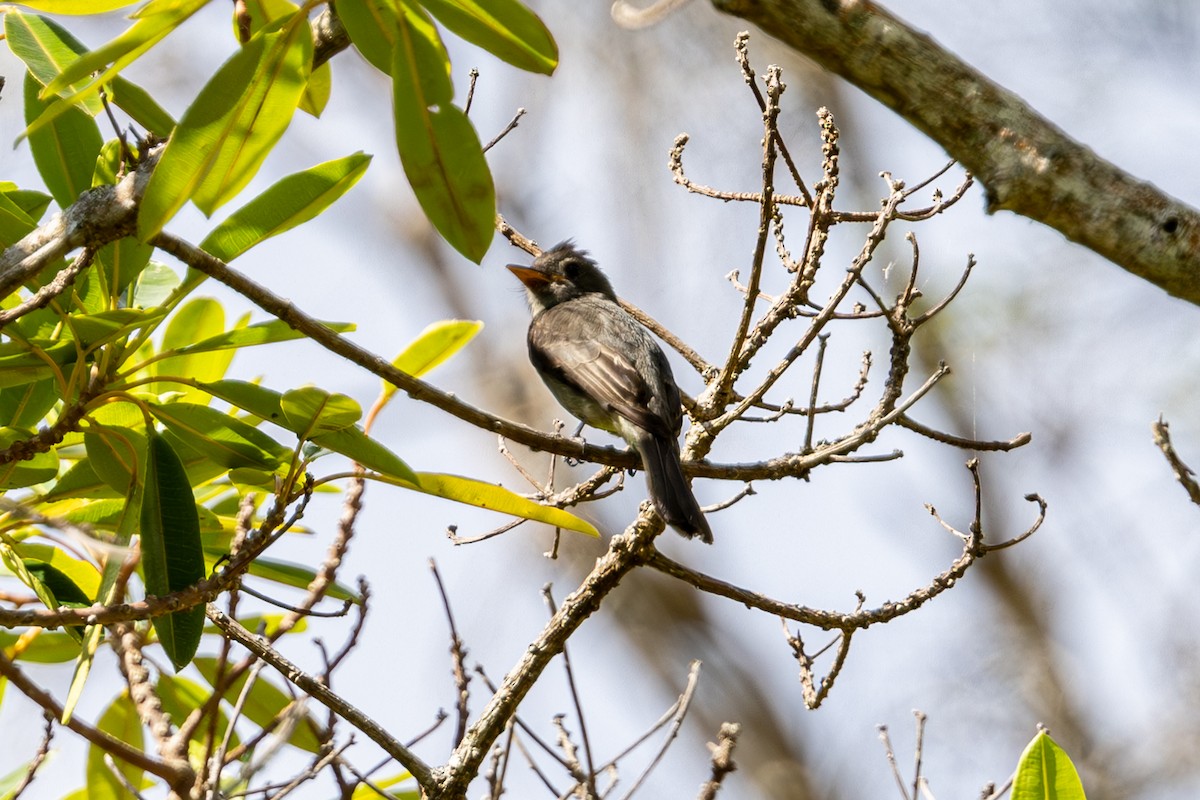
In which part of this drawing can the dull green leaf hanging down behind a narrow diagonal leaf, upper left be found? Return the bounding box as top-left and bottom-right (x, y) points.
(25, 72), (104, 209)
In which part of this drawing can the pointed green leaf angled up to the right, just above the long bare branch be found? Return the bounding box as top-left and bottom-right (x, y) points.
(200, 152), (371, 261)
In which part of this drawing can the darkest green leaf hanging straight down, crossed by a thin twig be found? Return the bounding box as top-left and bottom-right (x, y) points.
(140, 427), (204, 672)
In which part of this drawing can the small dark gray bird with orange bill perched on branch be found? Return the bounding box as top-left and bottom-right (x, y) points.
(509, 242), (713, 543)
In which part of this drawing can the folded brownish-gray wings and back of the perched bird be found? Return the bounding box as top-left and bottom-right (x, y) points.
(529, 303), (679, 439)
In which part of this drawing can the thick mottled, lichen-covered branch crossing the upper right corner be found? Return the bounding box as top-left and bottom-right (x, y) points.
(713, 0), (1200, 305)
